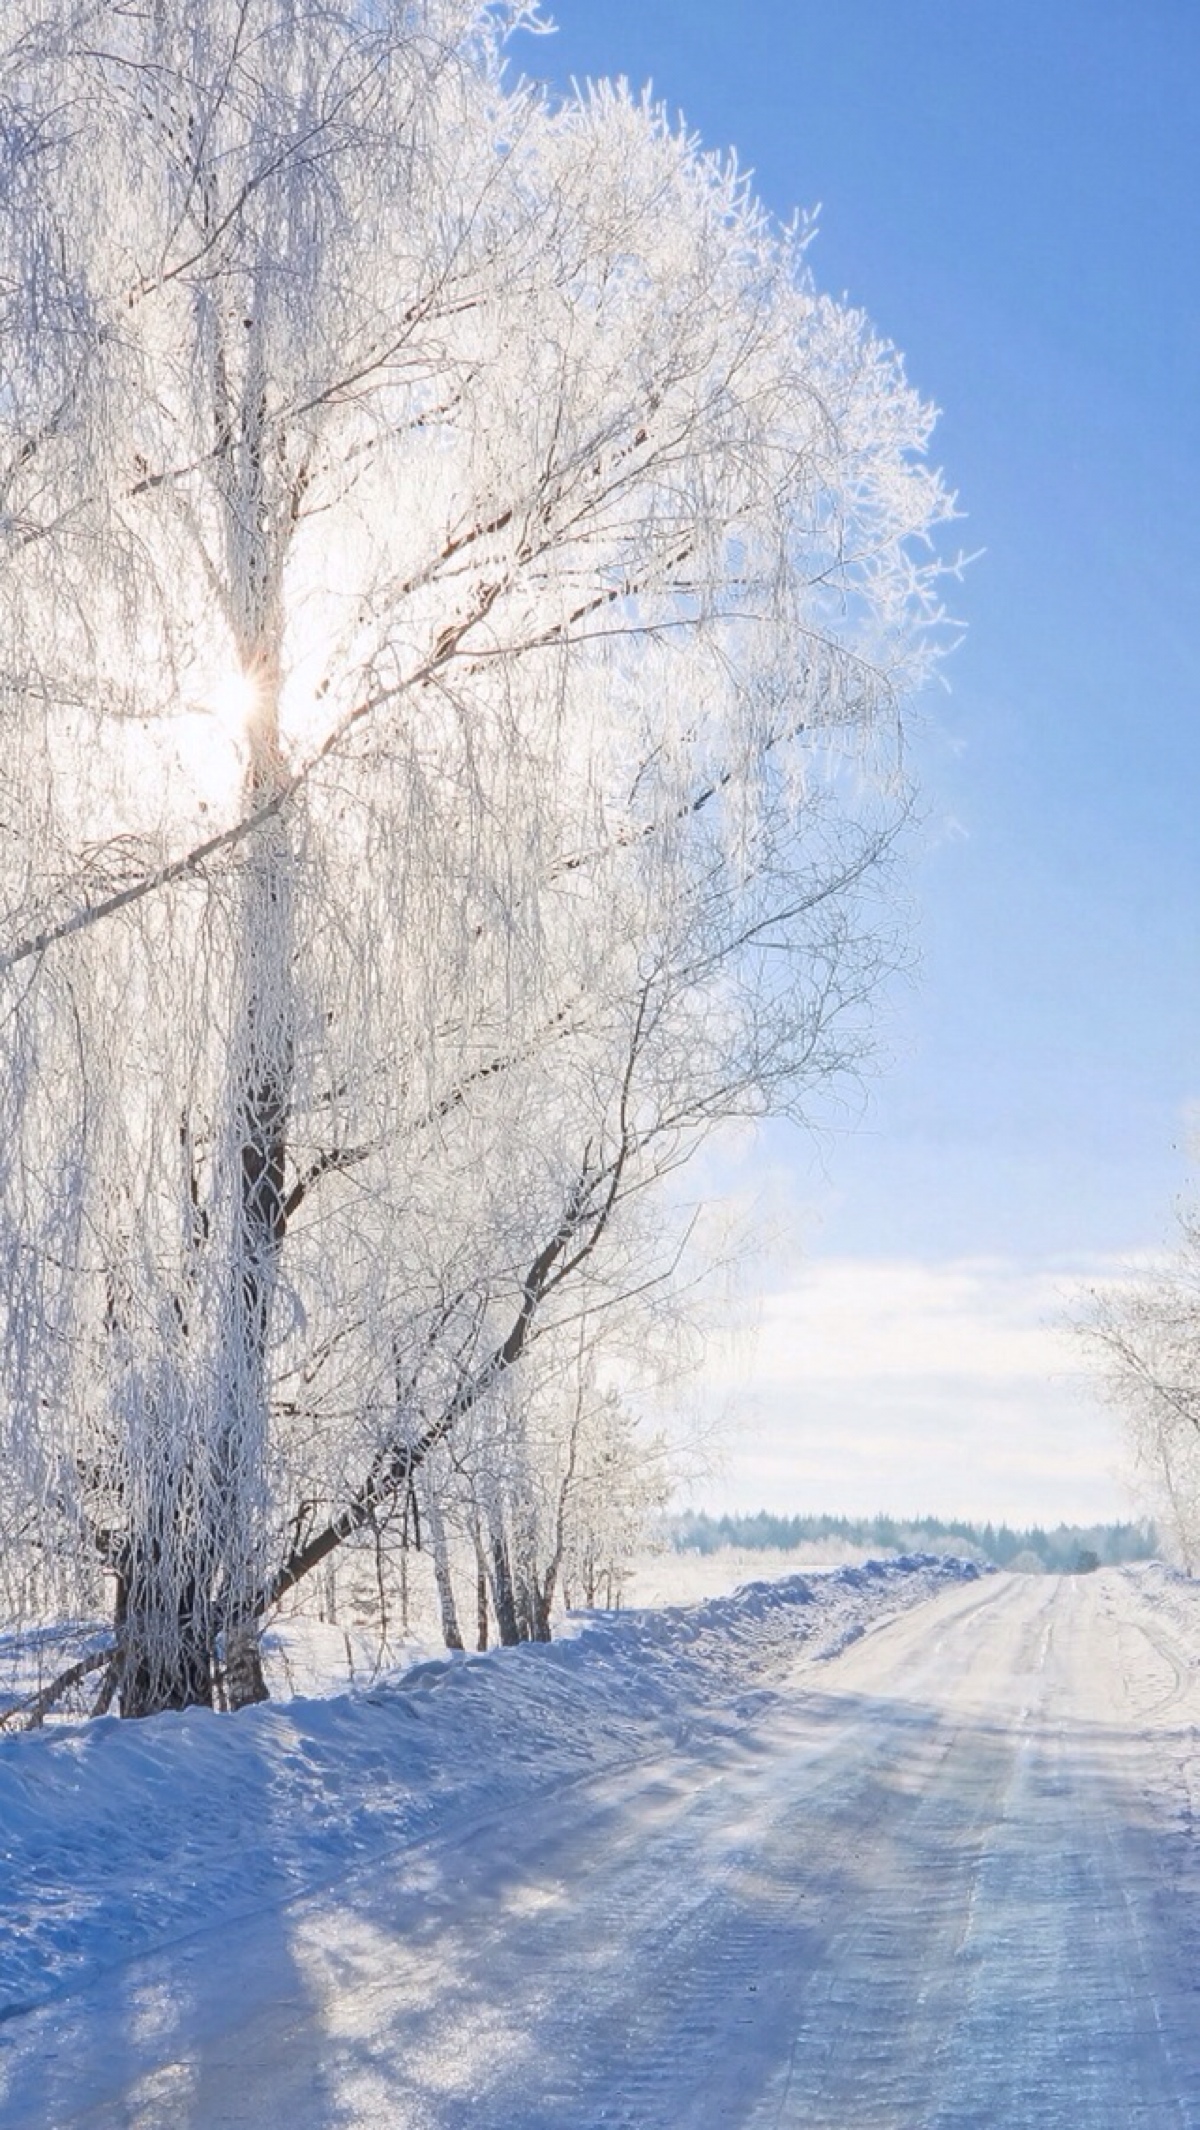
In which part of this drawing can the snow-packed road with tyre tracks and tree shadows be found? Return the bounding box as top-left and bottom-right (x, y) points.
(11, 1574), (1200, 2130)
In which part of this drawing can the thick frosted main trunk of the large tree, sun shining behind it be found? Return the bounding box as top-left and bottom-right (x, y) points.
(110, 617), (294, 1715)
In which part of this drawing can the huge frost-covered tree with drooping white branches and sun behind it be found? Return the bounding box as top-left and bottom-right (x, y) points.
(0, 0), (946, 1715)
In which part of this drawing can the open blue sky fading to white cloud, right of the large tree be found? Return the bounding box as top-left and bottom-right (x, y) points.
(520, 0), (1200, 1514)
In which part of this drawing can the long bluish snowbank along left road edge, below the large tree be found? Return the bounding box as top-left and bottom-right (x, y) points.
(0, 1555), (978, 2017)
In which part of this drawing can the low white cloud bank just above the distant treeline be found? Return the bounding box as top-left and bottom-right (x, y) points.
(682, 1259), (1130, 1523)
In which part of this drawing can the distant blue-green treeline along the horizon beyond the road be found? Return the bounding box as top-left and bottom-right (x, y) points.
(669, 1510), (1157, 1574)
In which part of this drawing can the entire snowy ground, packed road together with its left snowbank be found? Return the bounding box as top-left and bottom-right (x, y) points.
(0, 1561), (1200, 2130)
